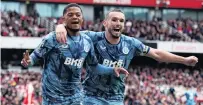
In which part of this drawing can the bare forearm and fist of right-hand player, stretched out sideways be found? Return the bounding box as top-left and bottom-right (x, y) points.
(146, 48), (198, 66)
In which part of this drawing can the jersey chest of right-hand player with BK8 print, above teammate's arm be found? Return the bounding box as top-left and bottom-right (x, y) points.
(95, 43), (133, 67)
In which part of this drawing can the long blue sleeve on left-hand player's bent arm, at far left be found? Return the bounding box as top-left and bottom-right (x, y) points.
(30, 33), (55, 65)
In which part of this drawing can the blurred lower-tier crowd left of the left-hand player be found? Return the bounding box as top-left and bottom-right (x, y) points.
(0, 71), (42, 105)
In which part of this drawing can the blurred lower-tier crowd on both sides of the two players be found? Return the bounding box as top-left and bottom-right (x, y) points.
(1, 66), (203, 105)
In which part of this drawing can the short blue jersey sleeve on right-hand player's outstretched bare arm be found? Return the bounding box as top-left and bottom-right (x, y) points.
(132, 38), (150, 56)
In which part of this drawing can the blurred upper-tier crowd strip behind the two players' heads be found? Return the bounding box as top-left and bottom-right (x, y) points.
(1, 11), (203, 42)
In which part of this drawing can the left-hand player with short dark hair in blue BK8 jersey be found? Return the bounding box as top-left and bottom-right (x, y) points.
(21, 4), (128, 105)
